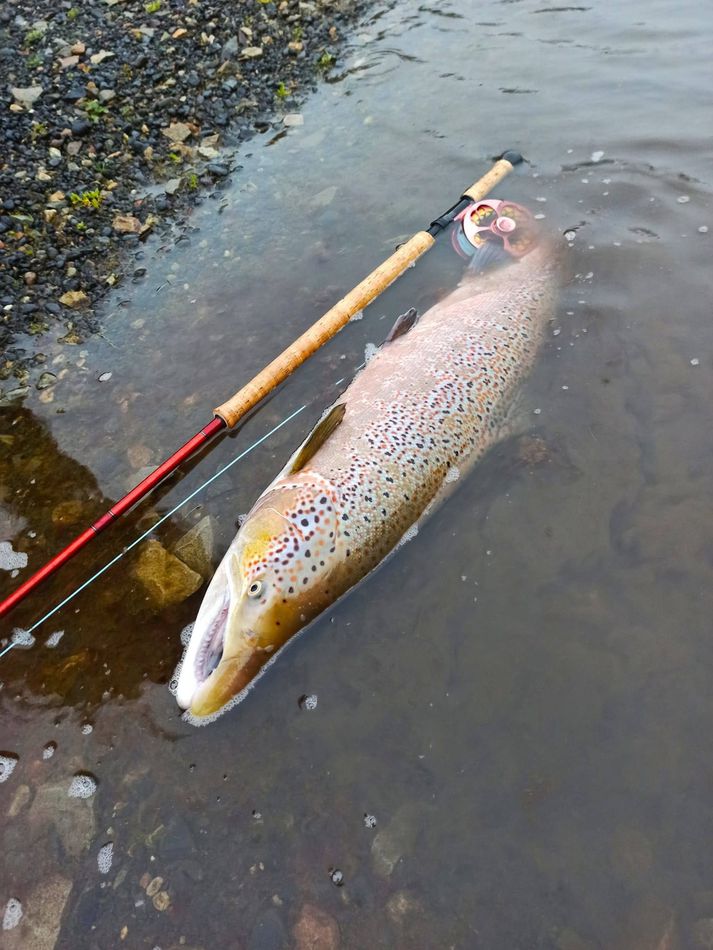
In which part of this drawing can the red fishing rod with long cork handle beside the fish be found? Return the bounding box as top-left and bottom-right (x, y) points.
(0, 151), (523, 617)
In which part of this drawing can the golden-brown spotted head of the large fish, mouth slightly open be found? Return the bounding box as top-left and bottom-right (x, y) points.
(176, 473), (339, 716)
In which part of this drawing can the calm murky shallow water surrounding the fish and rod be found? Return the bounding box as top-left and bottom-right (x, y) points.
(0, 0), (713, 950)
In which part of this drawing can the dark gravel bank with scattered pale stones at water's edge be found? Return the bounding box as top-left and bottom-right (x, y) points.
(0, 0), (368, 399)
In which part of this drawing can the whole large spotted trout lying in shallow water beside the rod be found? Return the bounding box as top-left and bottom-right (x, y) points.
(175, 232), (558, 718)
